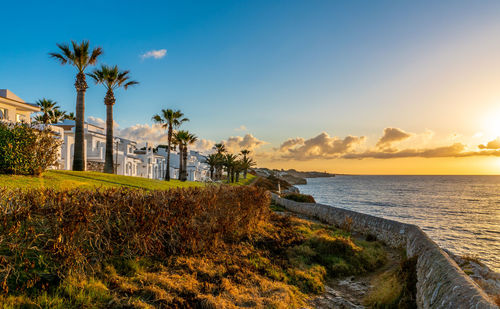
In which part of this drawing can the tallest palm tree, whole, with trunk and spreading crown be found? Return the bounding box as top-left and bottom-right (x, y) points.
(49, 41), (102, 171)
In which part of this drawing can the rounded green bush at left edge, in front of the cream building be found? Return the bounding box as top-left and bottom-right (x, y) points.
(0, 122), (60, 175)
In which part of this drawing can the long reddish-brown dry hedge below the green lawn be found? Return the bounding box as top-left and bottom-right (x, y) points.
(0, 186), (269, 291)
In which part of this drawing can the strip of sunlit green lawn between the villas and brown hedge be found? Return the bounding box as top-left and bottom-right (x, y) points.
(0, 171), (204, 190)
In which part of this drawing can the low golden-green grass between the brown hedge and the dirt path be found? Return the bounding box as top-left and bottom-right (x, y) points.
(0, 201), (392, 308)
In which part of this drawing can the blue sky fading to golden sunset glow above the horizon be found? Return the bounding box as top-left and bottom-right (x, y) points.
(0, 1), (500, 174)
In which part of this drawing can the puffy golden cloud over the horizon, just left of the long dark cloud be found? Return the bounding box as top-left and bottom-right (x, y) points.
(280, 132), (366, 161)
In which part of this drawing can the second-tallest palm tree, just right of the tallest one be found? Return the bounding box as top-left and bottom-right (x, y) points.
(87, 65), (139, 174)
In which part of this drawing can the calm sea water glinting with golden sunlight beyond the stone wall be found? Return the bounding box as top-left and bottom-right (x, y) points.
(297, 176), (500, 271)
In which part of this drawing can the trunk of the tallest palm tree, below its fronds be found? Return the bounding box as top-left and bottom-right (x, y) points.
(73, 73), (88, 171)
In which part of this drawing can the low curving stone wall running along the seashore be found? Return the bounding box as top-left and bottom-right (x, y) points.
(271, 193), (498, 309)
